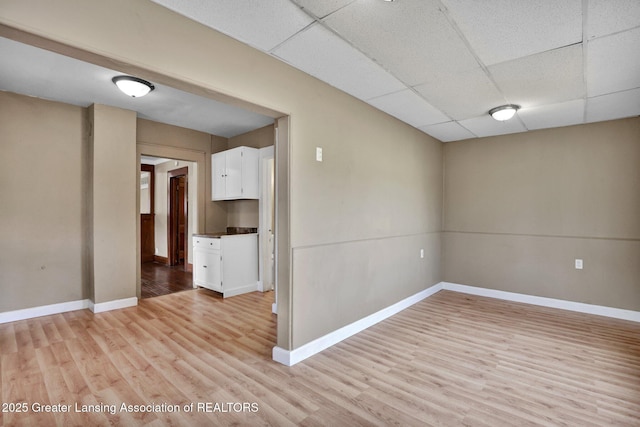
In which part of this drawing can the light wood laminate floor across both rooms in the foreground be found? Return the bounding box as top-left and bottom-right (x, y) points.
(0, 289), (640, 427)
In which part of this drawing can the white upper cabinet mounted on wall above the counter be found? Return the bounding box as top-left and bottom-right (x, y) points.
(211, 147), (260, 200)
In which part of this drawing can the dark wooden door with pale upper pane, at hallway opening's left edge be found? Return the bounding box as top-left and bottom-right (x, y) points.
(140, 165), (156, 263)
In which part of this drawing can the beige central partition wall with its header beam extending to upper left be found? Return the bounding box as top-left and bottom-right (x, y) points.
(0, 0), (442, 349)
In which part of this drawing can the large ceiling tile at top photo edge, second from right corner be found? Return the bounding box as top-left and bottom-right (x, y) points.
(442, 0), (582, 65)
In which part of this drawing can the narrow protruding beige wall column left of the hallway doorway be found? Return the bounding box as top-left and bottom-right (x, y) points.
(89, 104), (140, 304)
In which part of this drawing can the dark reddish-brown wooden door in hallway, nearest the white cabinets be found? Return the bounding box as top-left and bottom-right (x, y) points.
(168, 168), (189, 268)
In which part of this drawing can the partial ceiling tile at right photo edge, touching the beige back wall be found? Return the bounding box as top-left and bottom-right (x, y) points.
(586, 88), (640, 122)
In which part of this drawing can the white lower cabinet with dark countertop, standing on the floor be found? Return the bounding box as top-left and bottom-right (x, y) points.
(193, 234), (258, 297)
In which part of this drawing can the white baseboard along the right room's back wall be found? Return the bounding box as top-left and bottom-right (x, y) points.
(441, 282), (640, 322)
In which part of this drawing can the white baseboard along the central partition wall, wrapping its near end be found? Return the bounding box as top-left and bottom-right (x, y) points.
(272, 283), (442, 366)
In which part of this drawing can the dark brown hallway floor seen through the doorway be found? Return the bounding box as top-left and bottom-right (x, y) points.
(140, 262), (193, 298)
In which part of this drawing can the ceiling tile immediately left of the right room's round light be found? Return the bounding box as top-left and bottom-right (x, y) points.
(414, 68), (506, 120)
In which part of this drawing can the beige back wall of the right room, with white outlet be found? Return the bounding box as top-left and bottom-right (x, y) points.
(443, 118), (640, 310)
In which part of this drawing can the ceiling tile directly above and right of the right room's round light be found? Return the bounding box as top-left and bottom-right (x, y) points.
(488, 45), (586, 107)
